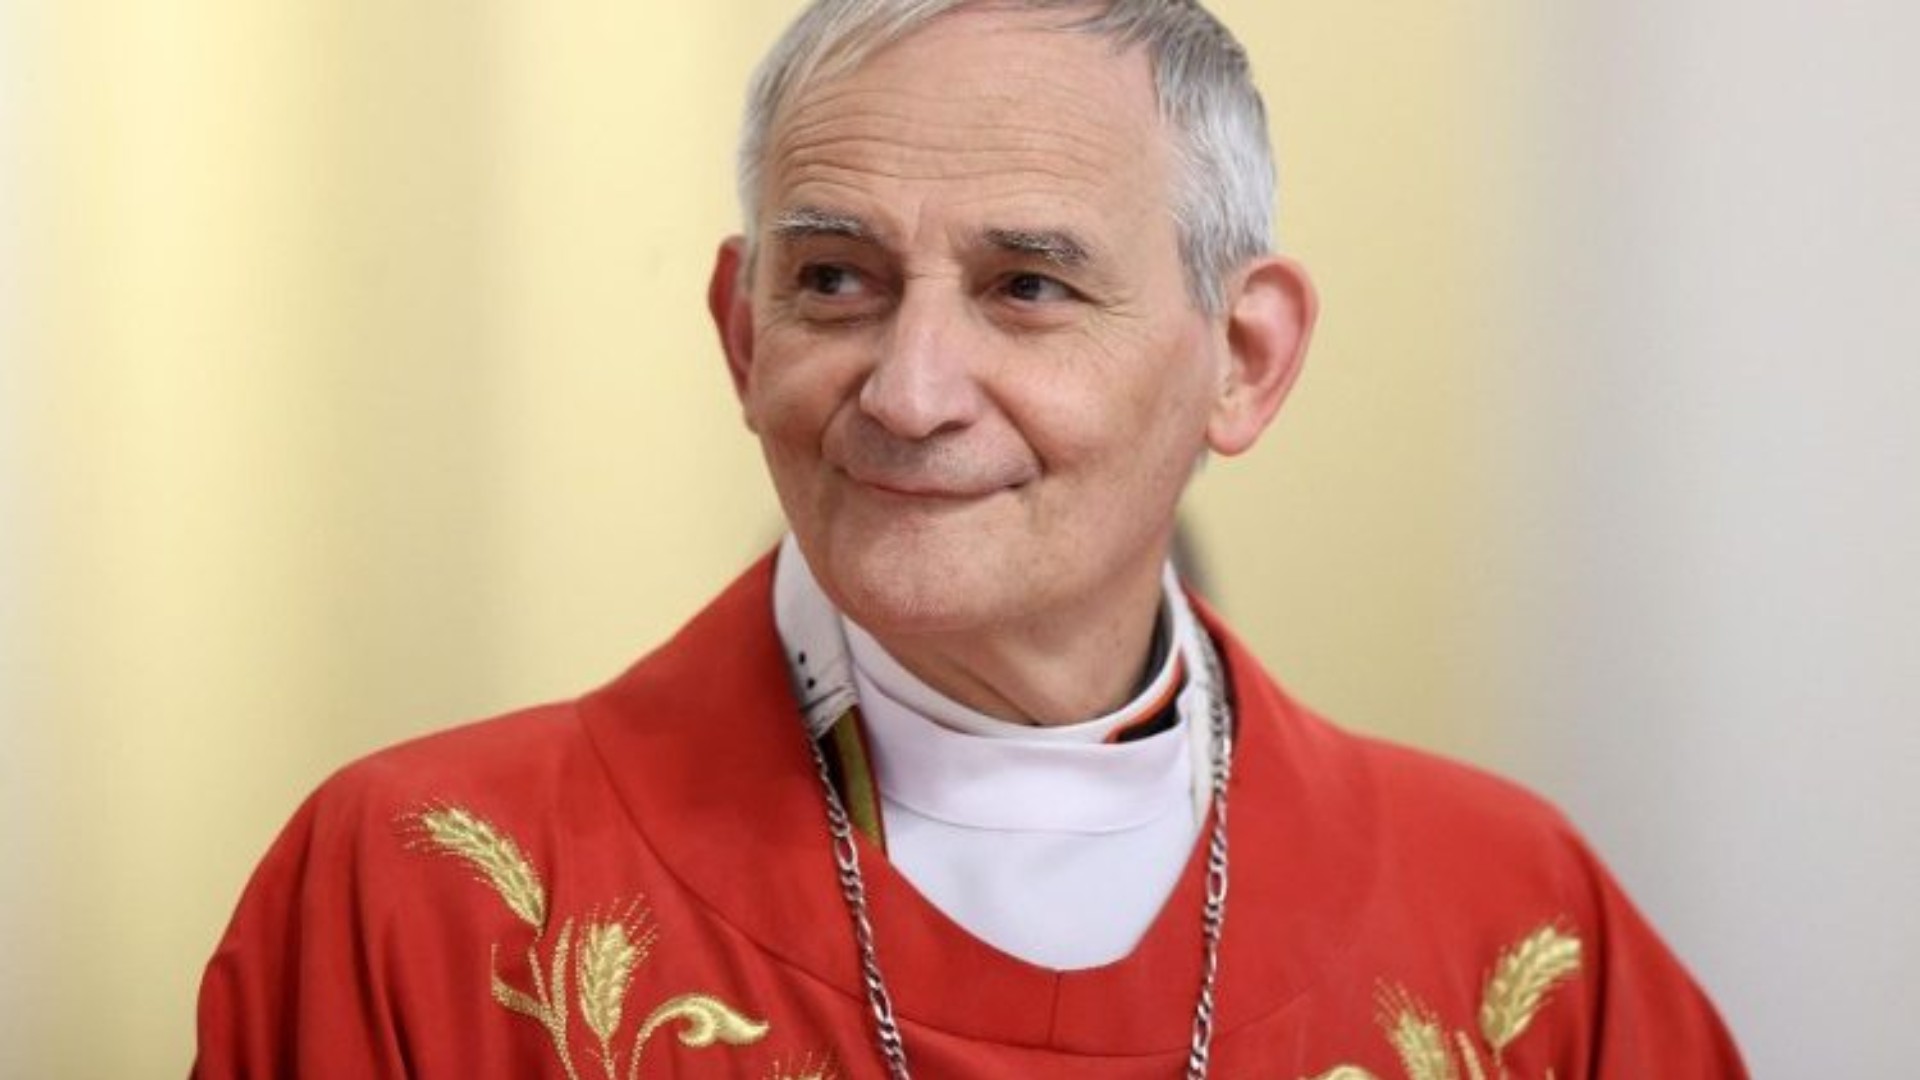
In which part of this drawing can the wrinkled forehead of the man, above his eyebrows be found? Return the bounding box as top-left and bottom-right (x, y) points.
(762, 10), (1169, 242)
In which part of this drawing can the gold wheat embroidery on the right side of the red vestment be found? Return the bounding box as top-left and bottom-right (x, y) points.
(1315, 922), (1580, 1080)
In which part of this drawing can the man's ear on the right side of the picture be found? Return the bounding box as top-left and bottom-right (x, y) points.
(1206, 256), (1319, 455)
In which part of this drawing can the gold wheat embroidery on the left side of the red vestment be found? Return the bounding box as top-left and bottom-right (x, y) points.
(405, 805), (768, 1080)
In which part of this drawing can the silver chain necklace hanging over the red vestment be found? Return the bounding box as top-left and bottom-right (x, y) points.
(806, 630), (1233, 1080)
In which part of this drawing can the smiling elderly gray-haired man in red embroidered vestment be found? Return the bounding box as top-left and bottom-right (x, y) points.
(198, 0), (1741, 1080)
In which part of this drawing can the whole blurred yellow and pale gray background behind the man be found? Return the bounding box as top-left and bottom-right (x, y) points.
(0, 0), (1920, 1078)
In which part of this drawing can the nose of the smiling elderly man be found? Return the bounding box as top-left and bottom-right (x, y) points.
(860, 281), (985, 440)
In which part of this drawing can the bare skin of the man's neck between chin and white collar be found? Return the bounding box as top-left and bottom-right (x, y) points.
(874, 573), (1162, 726)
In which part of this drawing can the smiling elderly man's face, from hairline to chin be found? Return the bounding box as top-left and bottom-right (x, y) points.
(716, 12), (1227, 636)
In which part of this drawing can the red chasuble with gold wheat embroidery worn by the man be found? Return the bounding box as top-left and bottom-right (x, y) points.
(194, 561), (1745, 1080)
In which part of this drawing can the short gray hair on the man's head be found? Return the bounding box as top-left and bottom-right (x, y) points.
(737, 0), (1275, 313)
